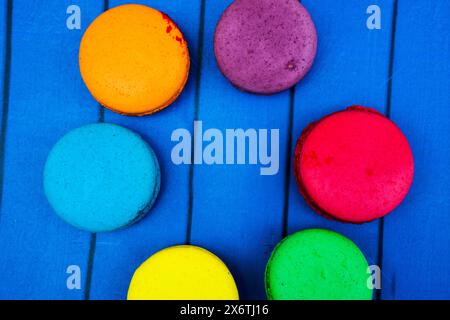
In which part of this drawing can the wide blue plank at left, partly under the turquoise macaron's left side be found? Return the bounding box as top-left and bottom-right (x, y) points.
(0, 0), (101, 299)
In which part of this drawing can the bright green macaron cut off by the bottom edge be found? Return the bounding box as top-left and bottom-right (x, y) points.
(265, 229), (372, 300)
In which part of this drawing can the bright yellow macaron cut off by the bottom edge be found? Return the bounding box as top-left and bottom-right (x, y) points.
(127, 245), (239, 300)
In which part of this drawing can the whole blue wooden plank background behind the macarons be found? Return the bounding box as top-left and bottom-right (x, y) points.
(0, 0), (450, 299)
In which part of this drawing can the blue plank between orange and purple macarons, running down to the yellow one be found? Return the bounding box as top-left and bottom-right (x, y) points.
(90, 0), (201, 299)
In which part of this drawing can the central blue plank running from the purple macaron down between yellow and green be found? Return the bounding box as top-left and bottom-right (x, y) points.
(191, 0), (289, 299)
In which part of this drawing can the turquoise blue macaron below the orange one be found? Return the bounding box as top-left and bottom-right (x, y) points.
(44, 123), (161, 232)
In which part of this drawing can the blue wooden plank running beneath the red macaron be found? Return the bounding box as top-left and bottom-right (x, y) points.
(287, 0), (395, 296)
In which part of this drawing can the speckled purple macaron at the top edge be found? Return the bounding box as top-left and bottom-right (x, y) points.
(214, 0), (317, 94)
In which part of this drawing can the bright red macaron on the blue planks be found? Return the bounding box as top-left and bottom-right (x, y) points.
(294, 106), (414, 223)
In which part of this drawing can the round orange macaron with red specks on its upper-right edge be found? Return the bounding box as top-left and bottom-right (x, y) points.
(79, 4), (190, 116)
